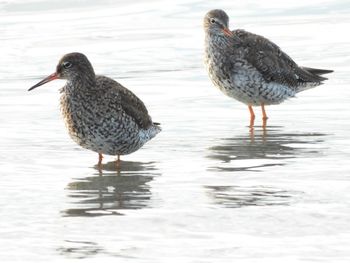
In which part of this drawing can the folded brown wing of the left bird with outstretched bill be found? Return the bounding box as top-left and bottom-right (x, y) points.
(96, 76), (152, 129)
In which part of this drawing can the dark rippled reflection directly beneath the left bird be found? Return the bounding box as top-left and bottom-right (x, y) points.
(63, 161), (159, 217)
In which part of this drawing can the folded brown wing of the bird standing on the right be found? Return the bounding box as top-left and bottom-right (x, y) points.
(232, 30), (326, 87)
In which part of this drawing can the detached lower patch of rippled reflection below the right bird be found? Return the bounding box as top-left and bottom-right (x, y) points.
(205, 186), (301, 208)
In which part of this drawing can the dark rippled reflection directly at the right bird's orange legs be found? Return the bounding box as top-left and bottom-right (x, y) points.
(207, 126), (326, 171)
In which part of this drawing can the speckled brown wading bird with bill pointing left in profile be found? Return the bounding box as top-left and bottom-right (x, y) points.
(28, 52), (161, 167)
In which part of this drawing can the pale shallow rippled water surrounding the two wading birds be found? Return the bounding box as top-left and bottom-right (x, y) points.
(0, 0), (350, 263)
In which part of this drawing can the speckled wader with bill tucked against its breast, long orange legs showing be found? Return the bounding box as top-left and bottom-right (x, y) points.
(203, 9), (333, 128)
